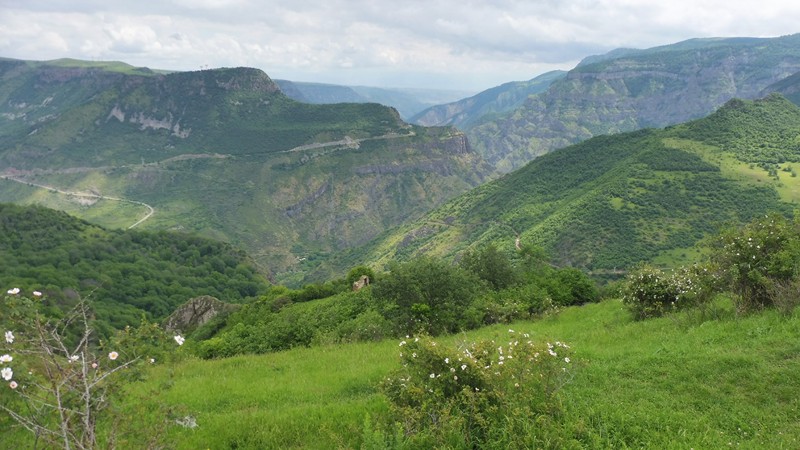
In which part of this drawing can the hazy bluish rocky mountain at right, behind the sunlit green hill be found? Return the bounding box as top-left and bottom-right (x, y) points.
(468, 35), (800, 172)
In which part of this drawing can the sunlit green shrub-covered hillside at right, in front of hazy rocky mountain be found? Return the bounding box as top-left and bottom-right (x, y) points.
(348, 95), (800, 274)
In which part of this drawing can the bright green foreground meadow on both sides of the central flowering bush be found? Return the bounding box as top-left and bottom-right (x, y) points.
(124, 301), (800, 449)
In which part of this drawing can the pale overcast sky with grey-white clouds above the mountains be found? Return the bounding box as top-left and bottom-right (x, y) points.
(0, 0), (800, 92)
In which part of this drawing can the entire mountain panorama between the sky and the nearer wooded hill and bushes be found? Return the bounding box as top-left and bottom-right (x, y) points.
(0, 35), (800, 284)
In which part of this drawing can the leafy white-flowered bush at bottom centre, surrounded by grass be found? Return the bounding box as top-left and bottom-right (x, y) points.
(382, 330), (573, 448)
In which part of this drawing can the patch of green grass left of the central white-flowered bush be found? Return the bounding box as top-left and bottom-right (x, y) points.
(121, 341), (397, 449)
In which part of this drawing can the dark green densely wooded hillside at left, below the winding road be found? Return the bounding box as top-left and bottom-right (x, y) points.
(0, 203), (269, 331)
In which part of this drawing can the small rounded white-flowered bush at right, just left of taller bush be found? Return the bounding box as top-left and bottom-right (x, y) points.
(622, 264), (718, 319)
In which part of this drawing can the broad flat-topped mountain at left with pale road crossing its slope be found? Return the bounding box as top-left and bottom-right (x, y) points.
(0, 60), (489, 282)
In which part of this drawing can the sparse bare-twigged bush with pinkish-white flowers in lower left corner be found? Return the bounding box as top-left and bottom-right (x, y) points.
(0, 288), (183, 449)
